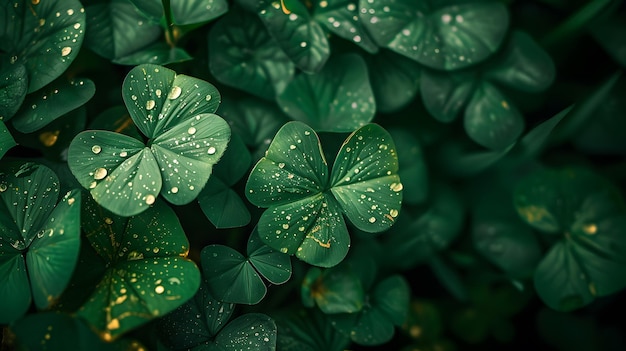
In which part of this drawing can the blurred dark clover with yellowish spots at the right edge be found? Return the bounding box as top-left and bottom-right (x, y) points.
(514, 169), (626, 311)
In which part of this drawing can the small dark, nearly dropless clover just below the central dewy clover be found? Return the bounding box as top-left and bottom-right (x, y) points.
(201, 228), (291, 305)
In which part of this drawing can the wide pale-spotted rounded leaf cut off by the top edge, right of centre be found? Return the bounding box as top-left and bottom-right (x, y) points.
(359, 0), (509, 70)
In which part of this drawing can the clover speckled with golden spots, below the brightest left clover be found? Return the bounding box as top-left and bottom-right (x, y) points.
(76, 195), (200, 340)
